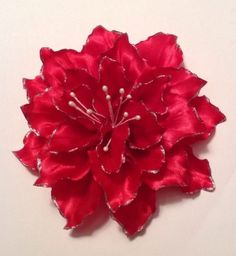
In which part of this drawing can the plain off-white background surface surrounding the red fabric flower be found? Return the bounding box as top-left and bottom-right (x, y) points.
(0, 0), (236, 256)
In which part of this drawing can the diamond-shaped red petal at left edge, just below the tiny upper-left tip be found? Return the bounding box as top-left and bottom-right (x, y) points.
(21, 92), (66, 137)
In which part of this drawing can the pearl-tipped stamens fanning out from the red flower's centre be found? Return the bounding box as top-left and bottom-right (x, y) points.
(68, 85), (141, 152)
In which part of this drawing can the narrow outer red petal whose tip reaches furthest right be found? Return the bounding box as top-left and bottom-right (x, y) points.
(191, 96), (225, 138)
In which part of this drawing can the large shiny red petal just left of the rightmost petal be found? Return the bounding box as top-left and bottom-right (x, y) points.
(159, 94), (205, 149)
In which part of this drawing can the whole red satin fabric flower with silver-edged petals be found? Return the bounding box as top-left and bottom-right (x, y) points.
(15, 26), (225, 235)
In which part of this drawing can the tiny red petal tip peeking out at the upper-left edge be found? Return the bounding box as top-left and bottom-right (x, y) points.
(23, 76), (48, 101)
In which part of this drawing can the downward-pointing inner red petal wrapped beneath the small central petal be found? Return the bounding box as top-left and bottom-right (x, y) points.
(90, 151), (141, 212)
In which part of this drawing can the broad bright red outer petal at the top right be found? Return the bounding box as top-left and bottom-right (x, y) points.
(136, 33), (183, 68)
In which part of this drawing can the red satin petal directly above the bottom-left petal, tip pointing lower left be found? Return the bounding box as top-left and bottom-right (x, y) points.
(35, 150), (90, 187)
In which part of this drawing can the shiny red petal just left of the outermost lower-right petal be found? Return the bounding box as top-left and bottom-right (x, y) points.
(143, 147), (188, 190)
